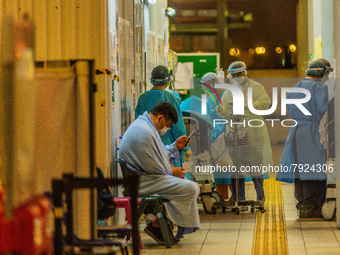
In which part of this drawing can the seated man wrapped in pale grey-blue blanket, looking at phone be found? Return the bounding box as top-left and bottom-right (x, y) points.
(119, 102), (200, 244)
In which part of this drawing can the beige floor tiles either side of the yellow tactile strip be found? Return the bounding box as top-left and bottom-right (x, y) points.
(141, 183), (340, 255)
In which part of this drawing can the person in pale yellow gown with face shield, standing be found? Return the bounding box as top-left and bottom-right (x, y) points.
(215, 61), (273, 205)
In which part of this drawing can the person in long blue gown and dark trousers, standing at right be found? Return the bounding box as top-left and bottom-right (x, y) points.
(276, 60), (328, 218)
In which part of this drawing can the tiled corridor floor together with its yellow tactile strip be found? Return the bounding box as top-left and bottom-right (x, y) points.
(142, 145), (340, 254)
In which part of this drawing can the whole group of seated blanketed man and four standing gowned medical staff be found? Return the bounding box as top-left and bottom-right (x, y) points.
(119, 59), (334, 244)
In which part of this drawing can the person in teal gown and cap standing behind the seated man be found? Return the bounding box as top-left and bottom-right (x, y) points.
(135, 65), (189, 167)
